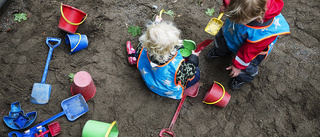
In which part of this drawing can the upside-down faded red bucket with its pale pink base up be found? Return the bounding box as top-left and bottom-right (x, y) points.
(71, 71), (96, 101)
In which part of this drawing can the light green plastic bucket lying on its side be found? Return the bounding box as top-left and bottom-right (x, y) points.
(82, 120), (119, 137)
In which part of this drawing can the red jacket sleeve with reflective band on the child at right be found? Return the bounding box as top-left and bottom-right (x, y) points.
(232, 36), (277, 69)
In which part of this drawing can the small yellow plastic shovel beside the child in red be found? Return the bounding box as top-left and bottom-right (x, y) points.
(204, 12), (223, 35)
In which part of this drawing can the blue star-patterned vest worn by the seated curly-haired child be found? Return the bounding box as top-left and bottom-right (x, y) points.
(137, 48), (184, 99)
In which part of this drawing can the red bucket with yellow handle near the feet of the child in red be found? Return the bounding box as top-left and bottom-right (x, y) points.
(203, 81), (231, 108)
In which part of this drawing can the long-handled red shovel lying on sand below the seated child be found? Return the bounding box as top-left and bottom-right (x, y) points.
(159, 82), (200, 137)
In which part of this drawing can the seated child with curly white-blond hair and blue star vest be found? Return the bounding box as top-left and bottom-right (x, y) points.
(127, 17), (200, 99)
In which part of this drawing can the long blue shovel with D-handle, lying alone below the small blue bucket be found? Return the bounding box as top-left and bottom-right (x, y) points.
(30, 37), (61, 104)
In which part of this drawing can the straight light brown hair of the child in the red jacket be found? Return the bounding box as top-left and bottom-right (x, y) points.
(224, 0), (267, 24)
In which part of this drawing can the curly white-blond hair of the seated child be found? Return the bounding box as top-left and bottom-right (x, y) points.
(139, 21), (181, 63)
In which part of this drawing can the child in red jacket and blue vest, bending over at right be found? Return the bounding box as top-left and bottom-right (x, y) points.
(208, 0), (290, 89)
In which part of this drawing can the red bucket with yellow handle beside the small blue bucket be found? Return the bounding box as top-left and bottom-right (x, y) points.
(58, 4), (87, 34)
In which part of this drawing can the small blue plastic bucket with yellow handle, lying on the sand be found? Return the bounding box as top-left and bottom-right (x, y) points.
(65, 33), (88, 54)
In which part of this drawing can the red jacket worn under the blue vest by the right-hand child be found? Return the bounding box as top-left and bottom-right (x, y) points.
(223, 0), (283, 69)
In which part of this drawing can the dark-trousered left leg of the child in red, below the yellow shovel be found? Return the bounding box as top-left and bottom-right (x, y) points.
(208, 29), (231, 59)
